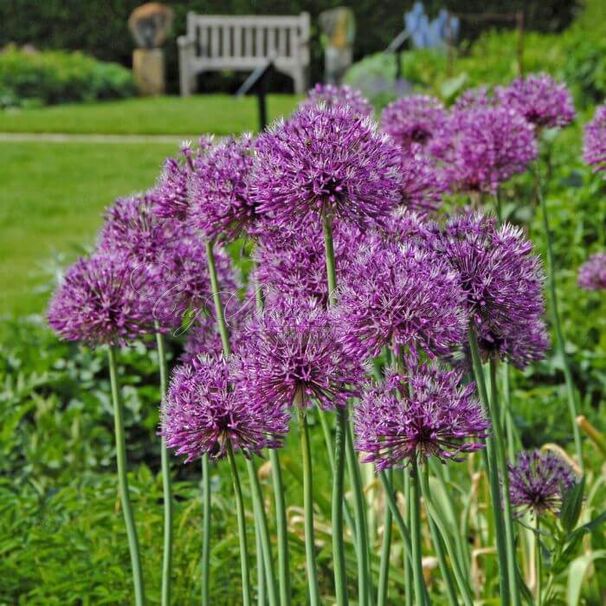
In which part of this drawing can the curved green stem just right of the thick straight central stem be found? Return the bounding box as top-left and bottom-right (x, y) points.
(346, 423), (373, 606)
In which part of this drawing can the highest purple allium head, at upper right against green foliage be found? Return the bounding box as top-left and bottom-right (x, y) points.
(495, 74), (574, 128)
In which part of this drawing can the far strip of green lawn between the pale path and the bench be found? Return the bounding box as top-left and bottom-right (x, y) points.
(0, 95), (297, 136)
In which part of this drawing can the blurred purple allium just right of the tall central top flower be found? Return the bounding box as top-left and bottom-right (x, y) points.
(381, 95), (446, 150)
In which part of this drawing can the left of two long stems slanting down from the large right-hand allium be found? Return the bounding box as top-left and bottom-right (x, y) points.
(469, 328), (513, 606)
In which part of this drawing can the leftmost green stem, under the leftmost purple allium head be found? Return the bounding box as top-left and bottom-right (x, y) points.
(108, 347), (145, 606)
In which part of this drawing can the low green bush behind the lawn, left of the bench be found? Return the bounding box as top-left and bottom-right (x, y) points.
(0, 48), (135, 106)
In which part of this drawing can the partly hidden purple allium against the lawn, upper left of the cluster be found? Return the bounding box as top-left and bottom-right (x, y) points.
(153, 137), (212, 220)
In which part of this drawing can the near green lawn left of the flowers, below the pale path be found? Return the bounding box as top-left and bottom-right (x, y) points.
(0, 143), (176, 315)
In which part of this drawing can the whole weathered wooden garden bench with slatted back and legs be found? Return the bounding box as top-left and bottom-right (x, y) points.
(177, 12), (310, 96)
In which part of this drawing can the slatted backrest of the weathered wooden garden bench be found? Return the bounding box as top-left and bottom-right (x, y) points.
(187, 13), (310, 69)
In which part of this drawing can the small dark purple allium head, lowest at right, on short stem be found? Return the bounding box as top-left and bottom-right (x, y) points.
(509, 450), (576, 515)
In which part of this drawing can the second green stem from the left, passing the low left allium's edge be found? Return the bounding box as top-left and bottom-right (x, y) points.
(156, 330), (173, 606)
